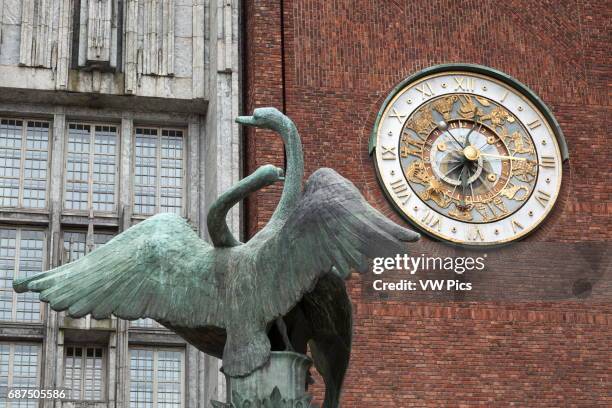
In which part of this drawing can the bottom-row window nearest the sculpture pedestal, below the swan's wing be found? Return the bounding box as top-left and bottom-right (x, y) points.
(130, 348), (184, 408)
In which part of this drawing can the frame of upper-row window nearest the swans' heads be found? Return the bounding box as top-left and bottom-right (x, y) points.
(130, 123), (189, 220)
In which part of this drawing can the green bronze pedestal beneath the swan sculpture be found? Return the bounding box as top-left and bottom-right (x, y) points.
(213, 351), (312, 408)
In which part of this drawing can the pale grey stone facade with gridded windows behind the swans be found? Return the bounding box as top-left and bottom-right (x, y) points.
(0, 0), (241, 408)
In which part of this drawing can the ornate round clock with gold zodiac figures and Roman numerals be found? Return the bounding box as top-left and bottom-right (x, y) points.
(373, 68), (563, 245)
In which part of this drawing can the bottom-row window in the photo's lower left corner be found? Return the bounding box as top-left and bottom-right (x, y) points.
(0, 343), (40, 408)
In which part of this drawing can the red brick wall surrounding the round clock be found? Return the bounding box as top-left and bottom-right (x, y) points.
(244, 0), (612, 407)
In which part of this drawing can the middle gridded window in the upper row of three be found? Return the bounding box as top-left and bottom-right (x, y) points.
(64, 123), (118, 212)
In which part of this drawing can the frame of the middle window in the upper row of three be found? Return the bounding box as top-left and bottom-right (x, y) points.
(61, 120), (121, 216)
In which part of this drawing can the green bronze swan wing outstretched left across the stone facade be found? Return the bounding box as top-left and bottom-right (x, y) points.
(14, 214), (223, 327)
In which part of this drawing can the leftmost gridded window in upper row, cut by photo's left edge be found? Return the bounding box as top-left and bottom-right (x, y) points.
(0, 119), (49, 208)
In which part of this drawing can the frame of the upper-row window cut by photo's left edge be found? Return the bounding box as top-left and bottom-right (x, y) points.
(0, 116), (53, 214)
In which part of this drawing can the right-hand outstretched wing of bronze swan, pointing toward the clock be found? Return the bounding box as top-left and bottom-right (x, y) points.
(252, 168), (419, 318)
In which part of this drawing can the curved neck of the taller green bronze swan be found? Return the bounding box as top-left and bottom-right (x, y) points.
(268, 118), (304, 226)
